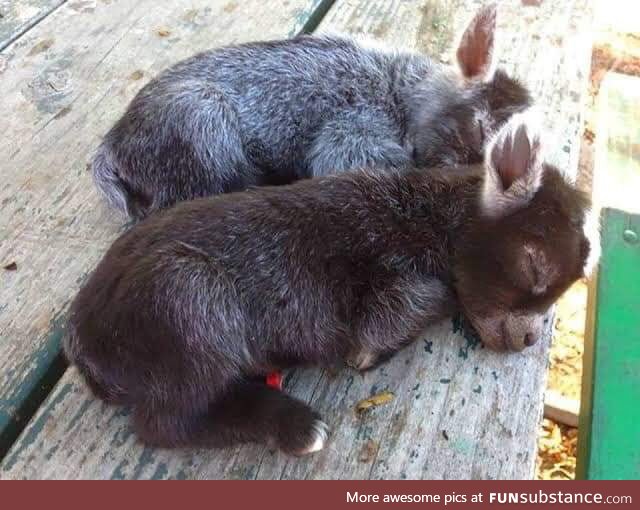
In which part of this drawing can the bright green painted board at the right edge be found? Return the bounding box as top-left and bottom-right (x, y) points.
(577, 209), (640, 480)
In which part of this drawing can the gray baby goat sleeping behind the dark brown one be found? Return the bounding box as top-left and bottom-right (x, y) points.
(92, 4), (531, 219)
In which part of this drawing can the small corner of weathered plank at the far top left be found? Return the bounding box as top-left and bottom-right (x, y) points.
(0, 0), (67, 51)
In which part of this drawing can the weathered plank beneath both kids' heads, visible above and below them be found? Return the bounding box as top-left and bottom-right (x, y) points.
(0, 0), (590, 478)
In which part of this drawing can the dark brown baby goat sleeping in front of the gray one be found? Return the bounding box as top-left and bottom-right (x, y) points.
(65, 115), (598, 454)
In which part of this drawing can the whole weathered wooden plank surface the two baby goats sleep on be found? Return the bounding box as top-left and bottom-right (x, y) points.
(0, 0), (591, 478)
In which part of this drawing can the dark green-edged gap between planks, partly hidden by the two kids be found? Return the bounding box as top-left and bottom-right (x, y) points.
(0, 0), (335, 460)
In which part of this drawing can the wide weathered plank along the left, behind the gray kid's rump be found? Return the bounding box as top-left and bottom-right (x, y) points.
(0, 0), (338, 452)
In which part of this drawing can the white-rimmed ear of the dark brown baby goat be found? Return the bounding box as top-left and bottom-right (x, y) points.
(481, 112), (544, 218)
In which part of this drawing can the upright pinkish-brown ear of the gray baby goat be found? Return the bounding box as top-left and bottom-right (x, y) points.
(457, 3), (498, 81)
